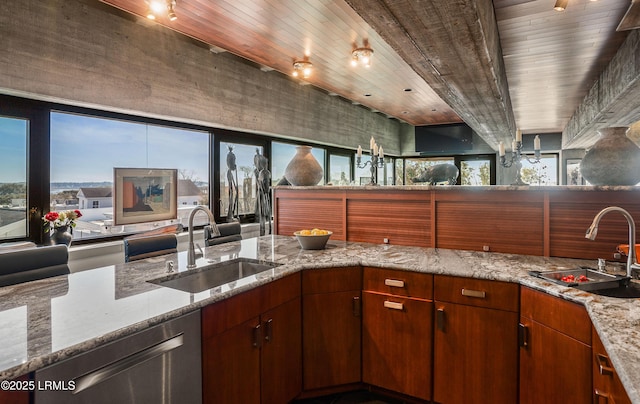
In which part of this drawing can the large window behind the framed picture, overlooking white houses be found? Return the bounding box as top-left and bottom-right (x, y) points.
(50, 112), (210, 239)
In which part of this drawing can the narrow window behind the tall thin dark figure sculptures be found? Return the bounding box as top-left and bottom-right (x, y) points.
(218, 142), (264, 218)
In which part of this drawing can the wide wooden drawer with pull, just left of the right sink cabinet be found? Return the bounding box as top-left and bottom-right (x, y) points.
(433, 275), (520, 312)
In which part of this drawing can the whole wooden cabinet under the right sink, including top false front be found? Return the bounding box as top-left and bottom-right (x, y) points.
(520, 287), (592, 404)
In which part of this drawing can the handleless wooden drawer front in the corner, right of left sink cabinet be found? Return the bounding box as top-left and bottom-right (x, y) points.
(302, 267), (362, 294)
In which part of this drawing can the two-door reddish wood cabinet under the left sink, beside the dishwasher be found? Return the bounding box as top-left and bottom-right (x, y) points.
(202, 274), (302, 404)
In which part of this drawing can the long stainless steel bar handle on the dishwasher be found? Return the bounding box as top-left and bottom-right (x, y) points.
(73, 333), (184, 394)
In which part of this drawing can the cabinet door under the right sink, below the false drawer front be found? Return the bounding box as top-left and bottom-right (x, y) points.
(520, 317), (591, 404)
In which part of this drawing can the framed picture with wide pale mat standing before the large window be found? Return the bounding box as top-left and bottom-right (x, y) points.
(113, 168), (178, 226)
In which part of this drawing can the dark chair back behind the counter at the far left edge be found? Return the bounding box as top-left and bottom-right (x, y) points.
(0, 245), (70, 286)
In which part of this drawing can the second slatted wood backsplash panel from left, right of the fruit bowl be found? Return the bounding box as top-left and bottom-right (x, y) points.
(347, 191), (431, 247)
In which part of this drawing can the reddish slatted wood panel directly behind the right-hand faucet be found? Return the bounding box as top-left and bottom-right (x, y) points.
(549, 190), (640, 258)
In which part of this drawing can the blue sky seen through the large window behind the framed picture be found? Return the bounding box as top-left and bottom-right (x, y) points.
(51, 113), (209, 182)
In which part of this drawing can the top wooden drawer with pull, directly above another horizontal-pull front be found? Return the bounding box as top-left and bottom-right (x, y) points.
(362, 267), (433, 299)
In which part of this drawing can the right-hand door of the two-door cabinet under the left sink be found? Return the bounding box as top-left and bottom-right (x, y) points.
(261, 297), (302, 404)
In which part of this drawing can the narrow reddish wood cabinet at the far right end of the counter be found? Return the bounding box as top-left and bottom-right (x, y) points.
(591, 329), (631, 404)
